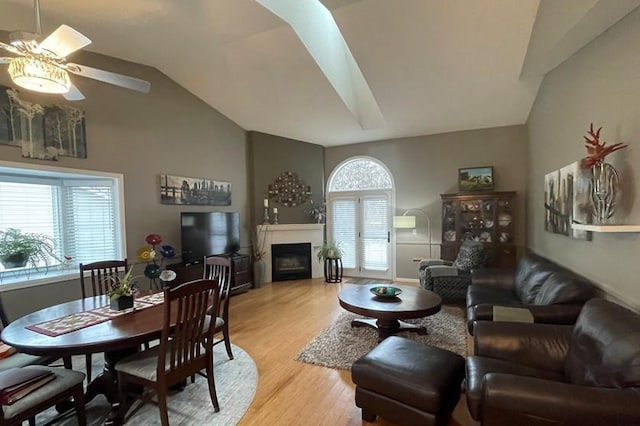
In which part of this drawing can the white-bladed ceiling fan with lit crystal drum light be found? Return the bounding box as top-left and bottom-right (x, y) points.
(0, 0), (151, 101)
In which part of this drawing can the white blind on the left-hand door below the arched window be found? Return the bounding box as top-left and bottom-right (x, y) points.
(331, 198), (358, 268)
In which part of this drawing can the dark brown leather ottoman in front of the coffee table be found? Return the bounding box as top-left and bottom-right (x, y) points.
(351, 336), (465, 425)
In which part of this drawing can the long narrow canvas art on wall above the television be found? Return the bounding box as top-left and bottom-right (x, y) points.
(160, 175), (231, 206)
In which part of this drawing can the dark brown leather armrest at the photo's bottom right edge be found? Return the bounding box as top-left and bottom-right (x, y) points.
(481, 373), (640, 426)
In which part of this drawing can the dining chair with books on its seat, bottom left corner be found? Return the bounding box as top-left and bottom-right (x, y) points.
(0, 366), (87, 426)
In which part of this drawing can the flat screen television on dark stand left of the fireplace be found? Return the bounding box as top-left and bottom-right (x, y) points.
(180, 212), (240, 263)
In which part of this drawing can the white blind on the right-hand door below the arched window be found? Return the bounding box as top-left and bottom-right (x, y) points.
(362, 196), (389, 271)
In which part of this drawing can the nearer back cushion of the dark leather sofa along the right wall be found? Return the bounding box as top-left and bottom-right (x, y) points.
(532, 269), (595, 305)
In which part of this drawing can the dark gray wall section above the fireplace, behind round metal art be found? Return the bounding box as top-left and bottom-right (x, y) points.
(247, 132), (324, 228)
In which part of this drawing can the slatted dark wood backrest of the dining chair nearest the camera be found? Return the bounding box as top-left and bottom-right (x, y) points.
(157, 279), (220, 385)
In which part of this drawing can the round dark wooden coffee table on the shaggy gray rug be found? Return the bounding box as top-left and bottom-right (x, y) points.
(338, 284), (442, 340)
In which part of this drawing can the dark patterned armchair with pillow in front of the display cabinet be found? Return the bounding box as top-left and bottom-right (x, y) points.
(419, 240), (487, 302)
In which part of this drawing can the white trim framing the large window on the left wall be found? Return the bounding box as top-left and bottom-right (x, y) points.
(0, 160), (127, 292)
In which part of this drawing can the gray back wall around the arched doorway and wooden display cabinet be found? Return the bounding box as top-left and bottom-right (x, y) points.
(325, 126), (527, 279)
